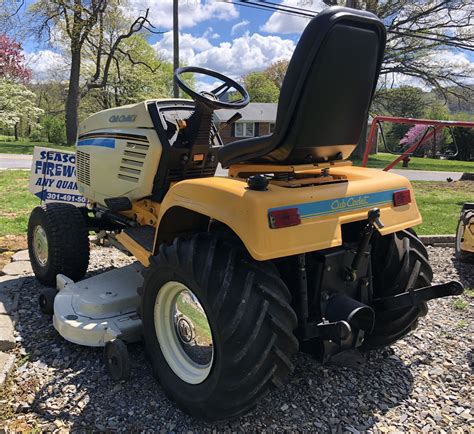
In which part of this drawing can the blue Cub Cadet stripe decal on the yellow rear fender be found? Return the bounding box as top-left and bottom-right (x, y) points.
(268, 188), (407, 218)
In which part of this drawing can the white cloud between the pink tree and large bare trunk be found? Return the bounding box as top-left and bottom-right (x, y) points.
(25, 50), (69, 82)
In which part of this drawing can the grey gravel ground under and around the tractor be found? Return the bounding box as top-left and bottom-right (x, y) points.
(0, 248), (474, 433)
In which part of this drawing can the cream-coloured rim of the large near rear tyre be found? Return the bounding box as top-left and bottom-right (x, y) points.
(154, 281), (214, 384)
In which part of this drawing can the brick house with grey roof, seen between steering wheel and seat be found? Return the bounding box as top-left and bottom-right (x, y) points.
(214, 102), (278, 144)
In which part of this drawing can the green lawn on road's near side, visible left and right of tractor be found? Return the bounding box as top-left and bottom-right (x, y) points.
(0, 170), (473, 236)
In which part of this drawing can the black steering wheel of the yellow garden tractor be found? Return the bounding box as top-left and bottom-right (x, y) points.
(174, 66), (250, 110)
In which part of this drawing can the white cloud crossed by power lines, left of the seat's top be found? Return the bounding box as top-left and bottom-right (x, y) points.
(260, 0), (327, 33)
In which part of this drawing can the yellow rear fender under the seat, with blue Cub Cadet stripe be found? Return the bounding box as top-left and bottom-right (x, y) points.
(155, 167), (421, 261)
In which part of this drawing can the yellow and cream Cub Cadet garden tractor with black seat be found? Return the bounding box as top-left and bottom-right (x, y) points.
(28, 7), (463, 420)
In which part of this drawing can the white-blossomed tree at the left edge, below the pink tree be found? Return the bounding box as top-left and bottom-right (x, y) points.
(0, 78), (43, 140)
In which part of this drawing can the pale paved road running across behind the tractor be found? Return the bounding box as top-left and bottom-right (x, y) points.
(0, 154), (462, 181)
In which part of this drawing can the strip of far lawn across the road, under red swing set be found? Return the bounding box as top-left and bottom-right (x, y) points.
(353, 152), (474, 173)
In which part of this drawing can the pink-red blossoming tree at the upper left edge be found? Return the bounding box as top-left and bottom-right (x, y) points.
(0, 35), (31, 83)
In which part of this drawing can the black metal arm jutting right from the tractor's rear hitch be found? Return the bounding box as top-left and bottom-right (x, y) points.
(371, 280), (464, 312)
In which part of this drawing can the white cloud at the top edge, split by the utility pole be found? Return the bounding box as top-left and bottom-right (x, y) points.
(127, 0), (239, 30)
